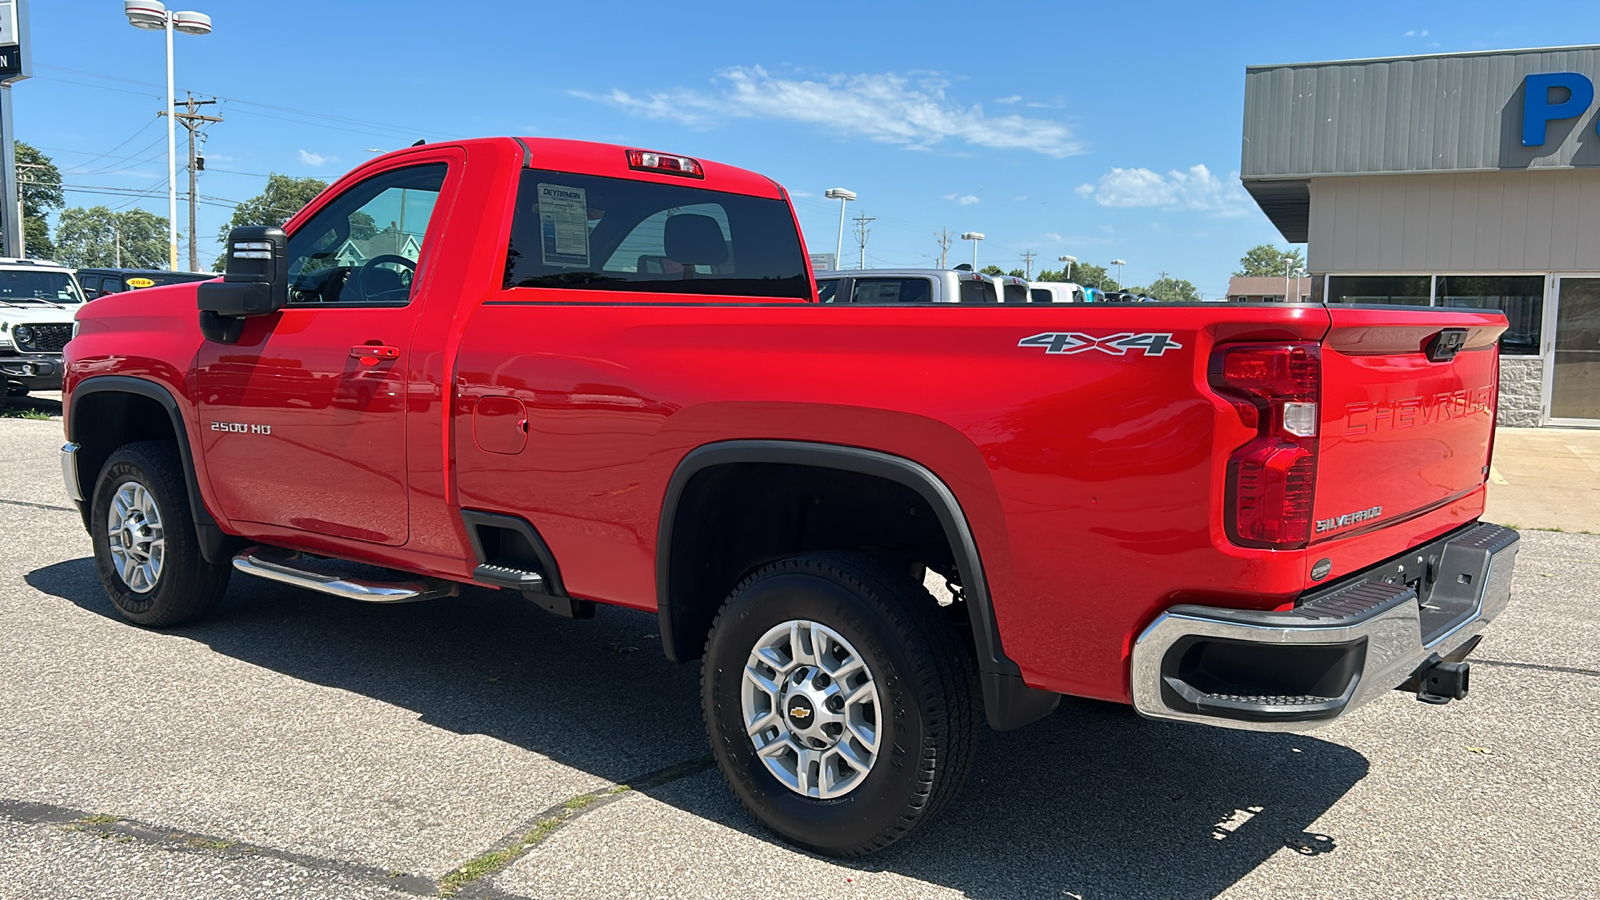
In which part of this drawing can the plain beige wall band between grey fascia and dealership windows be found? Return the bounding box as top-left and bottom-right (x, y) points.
(1307, 170), (1600, 274)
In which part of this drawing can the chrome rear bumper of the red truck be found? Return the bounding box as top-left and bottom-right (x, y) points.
(1131, 522), (1520, 732)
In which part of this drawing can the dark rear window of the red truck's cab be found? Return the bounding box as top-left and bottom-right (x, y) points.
(506, 170), (811, 299)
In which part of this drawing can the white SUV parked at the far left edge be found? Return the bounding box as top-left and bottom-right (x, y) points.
(0, 258), (83, 394)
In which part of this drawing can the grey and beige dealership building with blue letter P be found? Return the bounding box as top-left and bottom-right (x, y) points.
(1240, 46), (1600, 426)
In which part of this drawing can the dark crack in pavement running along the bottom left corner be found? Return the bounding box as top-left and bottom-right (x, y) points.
(0, 798), (438, 897)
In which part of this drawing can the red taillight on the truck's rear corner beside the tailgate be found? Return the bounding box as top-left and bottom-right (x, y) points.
(1211, 343), (1322, 549)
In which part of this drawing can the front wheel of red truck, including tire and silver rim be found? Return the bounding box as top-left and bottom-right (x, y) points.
(90, 440), (232, 628)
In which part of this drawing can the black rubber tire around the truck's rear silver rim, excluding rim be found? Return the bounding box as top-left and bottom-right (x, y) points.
(701, 552), (981, 857)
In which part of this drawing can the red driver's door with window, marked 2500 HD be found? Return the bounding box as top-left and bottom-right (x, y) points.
(197, 156), (459, 544)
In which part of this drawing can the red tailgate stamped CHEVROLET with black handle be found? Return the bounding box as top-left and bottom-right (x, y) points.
(1312, 304), (1506, 543)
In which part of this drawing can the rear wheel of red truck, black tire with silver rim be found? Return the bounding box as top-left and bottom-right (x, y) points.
(701, 552), (978, 857)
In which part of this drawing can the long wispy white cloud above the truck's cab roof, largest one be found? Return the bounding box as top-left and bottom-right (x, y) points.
(571, 66), (1083, 157)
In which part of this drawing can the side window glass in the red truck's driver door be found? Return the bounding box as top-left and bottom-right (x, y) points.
(288, 163), (448, 304)
